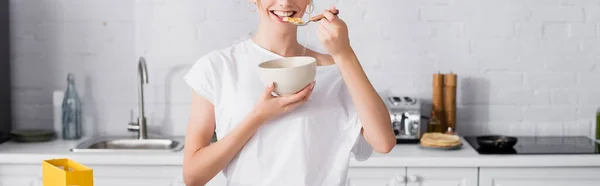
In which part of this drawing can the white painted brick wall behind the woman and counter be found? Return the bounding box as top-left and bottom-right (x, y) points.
(11, 0), (600, 135)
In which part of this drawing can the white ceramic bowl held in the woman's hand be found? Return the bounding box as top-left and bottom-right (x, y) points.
(258, 56), (317, 96)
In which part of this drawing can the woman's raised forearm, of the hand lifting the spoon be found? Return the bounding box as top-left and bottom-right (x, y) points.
(333, 50), (396, 153)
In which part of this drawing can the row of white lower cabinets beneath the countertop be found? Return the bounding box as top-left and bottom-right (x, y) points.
(7, 164), (600, 186)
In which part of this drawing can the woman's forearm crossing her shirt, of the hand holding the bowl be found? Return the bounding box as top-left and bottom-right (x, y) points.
(184, 114), (264, 186)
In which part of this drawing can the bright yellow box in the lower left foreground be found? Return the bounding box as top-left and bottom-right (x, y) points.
(42, 159), (94, 186)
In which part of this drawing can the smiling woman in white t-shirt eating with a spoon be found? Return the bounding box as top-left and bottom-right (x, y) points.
(183, 0), (395, 186)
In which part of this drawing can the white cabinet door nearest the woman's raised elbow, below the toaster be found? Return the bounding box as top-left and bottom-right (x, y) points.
(346, 167), (406, 186)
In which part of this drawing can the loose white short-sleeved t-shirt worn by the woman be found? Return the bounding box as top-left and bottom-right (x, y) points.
(184, 39), (373, 186)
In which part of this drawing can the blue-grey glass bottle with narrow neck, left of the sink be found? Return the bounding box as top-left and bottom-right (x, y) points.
(62, 73), (82, 140)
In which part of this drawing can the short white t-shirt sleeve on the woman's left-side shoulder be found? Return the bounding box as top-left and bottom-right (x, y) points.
(183, 54), (218, 104)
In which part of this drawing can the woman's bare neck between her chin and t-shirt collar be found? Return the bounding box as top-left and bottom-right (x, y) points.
(252, 24), (304, 57)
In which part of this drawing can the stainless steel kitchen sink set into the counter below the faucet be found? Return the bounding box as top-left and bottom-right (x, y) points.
(71, 137), (183, 152)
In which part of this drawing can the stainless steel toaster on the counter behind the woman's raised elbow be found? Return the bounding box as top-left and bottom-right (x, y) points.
(382, 96), (427, 143)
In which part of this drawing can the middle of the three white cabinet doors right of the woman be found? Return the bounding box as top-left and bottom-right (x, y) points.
(406, 167), (477, 186)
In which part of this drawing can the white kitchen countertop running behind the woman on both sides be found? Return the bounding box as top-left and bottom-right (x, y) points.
(0, 138), (600, 167)
